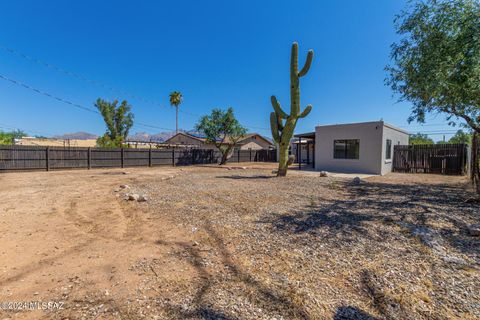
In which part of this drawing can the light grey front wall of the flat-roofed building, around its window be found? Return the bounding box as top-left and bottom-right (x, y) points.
(315, 121), (383, 174)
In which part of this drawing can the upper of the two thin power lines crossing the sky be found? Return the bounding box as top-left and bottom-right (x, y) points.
(0, 45), (270, 131)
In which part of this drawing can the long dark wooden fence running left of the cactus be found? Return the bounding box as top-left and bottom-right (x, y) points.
(0, 145), (276, 172)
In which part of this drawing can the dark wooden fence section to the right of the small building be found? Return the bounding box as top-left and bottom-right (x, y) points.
(393, 144), (468, 175)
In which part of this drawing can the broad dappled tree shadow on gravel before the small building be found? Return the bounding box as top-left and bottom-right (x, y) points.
(259, 182), (480, 256)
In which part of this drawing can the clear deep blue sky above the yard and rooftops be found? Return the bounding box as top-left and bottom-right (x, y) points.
(0, 0), (455, 140)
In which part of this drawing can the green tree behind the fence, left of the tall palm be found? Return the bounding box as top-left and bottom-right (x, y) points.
(95, 98), (133, 148)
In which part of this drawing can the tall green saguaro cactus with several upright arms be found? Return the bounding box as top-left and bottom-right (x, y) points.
(270, 42), (313, 177)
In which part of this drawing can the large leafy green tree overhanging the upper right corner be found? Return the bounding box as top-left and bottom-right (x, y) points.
(386, 0), (480, 133)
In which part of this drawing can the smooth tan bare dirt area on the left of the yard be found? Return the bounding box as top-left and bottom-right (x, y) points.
(0, 168), (197, 319)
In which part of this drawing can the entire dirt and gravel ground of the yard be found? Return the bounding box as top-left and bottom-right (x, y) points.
(0, 164), (480, 320)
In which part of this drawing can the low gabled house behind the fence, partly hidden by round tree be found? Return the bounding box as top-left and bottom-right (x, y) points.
(165, 132), (273, 150)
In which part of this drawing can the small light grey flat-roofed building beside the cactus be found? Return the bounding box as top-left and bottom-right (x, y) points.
(295, 121), (409, 175)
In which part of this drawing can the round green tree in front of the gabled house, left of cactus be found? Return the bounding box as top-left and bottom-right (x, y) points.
(195, 108), (247, 164)
